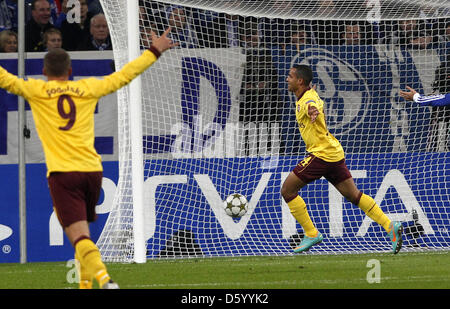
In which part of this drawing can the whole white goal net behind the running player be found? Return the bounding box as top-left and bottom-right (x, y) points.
(97, 0), (450, 262)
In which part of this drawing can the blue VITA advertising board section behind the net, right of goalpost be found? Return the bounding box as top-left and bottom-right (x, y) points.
(145, 153), (450, 257)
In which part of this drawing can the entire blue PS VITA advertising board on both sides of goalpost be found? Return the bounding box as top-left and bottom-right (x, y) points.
(0, 153), (450, 262)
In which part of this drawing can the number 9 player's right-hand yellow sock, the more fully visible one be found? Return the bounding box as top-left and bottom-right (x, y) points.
(75, 238), (111, 287)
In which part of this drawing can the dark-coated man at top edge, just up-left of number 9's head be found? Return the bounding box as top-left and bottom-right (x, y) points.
(25, 0), (53, 52)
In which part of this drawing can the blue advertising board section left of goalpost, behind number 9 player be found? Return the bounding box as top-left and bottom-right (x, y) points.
(0, 162), (118, 263)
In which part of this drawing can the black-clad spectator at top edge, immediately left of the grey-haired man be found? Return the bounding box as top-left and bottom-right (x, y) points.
(60, 0), (93, 51)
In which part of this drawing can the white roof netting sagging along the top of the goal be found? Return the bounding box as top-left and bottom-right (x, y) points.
(143, 0), (448, 20)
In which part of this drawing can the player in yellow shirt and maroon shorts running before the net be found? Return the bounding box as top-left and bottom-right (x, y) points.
(281, 64), (403, 254)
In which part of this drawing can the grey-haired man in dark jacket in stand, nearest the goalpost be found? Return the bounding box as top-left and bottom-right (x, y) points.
(78, 13), (112, 51)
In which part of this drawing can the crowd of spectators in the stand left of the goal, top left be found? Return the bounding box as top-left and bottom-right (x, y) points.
(0, 0), (107, 52)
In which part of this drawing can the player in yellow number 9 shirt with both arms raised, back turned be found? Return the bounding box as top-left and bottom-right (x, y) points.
(0, 28), (175, 289)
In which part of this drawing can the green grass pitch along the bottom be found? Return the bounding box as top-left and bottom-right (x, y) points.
(0, 251), (450, 290)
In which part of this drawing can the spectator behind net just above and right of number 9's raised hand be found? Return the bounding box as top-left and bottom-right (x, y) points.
(166, 5), (200, 48)
